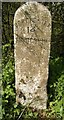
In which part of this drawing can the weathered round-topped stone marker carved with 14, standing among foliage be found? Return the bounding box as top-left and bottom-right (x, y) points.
(14, 2), (51, 109)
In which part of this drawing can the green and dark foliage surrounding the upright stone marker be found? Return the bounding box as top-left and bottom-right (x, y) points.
(2, 2), (64, 120)
